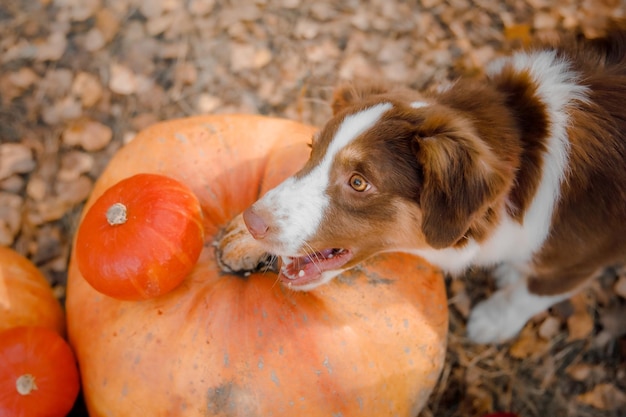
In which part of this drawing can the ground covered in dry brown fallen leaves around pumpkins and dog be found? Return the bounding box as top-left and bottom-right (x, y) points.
(0, 0), (626, 417)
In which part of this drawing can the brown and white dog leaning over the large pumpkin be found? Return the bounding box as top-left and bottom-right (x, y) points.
(222, 31), (626, 343)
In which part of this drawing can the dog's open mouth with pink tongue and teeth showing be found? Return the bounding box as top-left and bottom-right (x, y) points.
(278, 248), (352, 286)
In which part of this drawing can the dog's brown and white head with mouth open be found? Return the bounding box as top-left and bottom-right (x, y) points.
(244, 86), (510, 290)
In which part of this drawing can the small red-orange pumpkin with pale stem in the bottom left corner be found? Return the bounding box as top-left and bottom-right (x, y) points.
(0, 326), (80, 417)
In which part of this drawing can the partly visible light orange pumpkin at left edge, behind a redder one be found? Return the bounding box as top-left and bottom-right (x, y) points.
(0, 246), (65, 335)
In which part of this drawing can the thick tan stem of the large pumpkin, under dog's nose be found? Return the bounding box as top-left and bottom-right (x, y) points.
(213, 215), (272, 274)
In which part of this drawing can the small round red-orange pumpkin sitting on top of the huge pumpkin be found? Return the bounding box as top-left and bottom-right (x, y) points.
(76, 174), (204, 300)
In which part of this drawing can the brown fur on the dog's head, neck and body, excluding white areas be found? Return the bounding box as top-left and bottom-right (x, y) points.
(310, 27), (626, 294)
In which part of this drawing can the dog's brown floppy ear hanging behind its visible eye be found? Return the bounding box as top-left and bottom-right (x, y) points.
(414, 130), (508, 249)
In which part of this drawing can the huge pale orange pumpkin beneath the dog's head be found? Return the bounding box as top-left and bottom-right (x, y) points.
(66, 115), (448, 417)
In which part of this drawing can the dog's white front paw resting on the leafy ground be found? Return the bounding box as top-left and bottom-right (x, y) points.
(467, 291), (528, 343)
